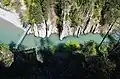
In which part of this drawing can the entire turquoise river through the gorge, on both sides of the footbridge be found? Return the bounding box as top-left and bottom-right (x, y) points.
(0, 18), (109, 48)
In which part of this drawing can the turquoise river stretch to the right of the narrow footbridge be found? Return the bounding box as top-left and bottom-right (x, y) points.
(22, 34), (109, 48)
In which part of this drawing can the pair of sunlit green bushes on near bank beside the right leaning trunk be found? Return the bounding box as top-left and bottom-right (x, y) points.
(82, 40), (113, 56)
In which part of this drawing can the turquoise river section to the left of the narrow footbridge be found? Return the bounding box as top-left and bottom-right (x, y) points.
(0, 18), (24, 44)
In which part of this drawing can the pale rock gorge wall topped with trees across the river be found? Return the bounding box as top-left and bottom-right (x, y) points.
(1, 0), (120, 39)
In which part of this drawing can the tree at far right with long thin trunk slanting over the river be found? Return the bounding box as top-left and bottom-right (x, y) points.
(98, 0), (120, 49)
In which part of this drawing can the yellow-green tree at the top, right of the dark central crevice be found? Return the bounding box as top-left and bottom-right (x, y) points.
(69, 0), (89, 36)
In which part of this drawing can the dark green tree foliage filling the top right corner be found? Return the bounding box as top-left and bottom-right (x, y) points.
(100, 0), (120, 25)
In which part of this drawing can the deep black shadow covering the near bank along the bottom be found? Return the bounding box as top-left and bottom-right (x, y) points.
(0, 40), (120, 79)
